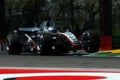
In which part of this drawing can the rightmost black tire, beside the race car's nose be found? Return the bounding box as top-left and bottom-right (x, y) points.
(82, 30), (100, 53)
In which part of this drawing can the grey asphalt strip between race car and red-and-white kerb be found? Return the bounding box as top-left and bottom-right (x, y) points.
(0, 52), (120, 70)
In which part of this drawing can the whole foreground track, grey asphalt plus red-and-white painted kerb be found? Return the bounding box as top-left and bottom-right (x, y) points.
(0, 52), (120, 80)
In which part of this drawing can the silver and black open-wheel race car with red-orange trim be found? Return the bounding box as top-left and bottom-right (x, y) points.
(6, 21), (100, 55)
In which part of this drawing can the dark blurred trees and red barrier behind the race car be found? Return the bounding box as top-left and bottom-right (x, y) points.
(0, 0), (120, 49)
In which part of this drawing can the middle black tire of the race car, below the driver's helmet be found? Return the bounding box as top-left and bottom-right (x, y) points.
(40, 33), (53, 55)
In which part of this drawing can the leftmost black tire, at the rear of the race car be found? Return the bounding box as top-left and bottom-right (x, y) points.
(5, 35), (22, 55)
